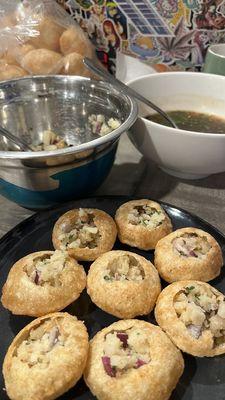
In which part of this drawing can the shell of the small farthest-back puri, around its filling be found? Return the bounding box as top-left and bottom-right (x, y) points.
(115, 199), (172, 250)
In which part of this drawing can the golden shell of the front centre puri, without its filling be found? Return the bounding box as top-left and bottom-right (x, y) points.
(84, 320), (184, 400)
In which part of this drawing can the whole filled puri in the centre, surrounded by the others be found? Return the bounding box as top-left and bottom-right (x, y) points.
(87, 250), (161, 318)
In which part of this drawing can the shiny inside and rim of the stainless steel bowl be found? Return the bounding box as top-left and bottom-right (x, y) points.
(0, 76), (138, 160)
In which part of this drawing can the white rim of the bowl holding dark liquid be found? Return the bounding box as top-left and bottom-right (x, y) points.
(126, 71), (225, 139)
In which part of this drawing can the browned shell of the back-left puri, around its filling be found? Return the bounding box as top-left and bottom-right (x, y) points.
(52, 208), (117, 261)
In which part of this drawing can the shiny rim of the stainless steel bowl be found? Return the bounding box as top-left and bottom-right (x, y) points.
(0, 75), (138, 160)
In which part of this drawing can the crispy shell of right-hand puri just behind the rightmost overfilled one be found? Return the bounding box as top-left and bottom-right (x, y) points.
(154, 228), (223, 282)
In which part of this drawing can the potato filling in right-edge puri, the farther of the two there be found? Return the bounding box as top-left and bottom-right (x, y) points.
(173, 233), (211, 258)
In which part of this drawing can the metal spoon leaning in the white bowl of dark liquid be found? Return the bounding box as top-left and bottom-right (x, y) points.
(83, 57), (177, 128)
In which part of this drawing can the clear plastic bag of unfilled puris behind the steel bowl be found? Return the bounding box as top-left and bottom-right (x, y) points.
(0, 0), (96, 81)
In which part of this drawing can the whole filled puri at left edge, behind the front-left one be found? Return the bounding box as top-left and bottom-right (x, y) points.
(1, 251), (86, 317)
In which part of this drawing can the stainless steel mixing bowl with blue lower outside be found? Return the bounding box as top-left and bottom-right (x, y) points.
(0, 76), (137, 208)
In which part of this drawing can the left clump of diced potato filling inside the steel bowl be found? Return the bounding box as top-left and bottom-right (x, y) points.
(31, 130), (69, 151)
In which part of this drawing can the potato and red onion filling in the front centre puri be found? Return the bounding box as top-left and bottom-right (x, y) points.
(102, 327), (151, 377)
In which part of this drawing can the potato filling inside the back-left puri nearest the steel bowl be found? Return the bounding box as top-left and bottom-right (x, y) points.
(59, 209), (101, 250)
